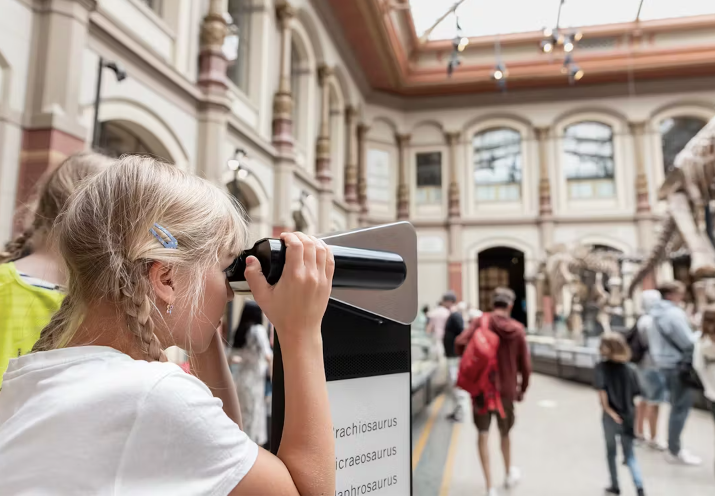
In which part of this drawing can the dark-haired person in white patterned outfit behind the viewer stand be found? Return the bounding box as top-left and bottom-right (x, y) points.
(231, 300), (273, 446)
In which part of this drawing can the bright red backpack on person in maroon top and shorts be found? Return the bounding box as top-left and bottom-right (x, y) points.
(457, 314), (504, 417)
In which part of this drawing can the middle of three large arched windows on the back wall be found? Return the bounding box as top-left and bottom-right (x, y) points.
(563, 122), (616, 199)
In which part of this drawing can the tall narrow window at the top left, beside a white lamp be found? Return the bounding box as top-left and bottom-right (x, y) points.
(224, 0), (252, 93)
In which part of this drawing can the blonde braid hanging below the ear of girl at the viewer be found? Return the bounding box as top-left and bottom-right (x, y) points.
(121, 264), (164, 361)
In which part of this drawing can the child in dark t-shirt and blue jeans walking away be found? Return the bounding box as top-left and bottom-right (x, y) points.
(596, 332), (645, 496)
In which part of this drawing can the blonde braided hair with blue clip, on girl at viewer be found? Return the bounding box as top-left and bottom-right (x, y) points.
(33, 156), (248, 360)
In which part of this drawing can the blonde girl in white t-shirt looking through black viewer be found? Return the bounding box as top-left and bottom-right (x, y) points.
(0, 156), (335, 496)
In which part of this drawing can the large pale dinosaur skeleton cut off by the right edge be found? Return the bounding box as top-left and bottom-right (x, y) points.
(628, 119), (715, 298)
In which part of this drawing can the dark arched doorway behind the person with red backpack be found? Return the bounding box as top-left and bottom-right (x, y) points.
(477, 246), (527, 326)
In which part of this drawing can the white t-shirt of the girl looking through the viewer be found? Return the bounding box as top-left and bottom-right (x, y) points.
(0, 346), (258, 496)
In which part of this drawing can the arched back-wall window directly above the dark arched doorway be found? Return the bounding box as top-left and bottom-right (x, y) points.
(472, 127), (521, 201)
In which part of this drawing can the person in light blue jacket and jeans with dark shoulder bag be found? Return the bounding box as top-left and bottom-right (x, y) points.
(647, 281), (701, 465)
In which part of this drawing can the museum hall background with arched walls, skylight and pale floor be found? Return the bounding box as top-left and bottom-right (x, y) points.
(0, 0), (715, 496)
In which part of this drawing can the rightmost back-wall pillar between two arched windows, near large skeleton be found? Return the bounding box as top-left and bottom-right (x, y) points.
(628, 121), (656, 289)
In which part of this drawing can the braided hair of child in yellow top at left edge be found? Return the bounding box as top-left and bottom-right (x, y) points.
(0, 152), (114, 263)
